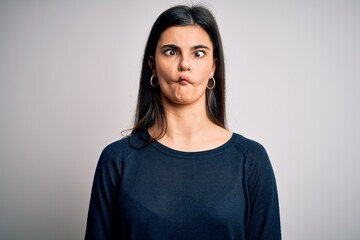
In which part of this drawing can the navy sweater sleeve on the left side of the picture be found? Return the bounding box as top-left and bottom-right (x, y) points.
(85, 144), (122, 240)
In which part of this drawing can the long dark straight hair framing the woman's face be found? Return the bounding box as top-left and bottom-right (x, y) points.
(131, 5), (226, 139)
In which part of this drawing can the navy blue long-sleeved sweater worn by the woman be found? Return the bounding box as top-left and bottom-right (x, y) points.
(85, 132), (281, 240)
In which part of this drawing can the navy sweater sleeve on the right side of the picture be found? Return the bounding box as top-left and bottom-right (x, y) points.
(242, 141), (281, 240)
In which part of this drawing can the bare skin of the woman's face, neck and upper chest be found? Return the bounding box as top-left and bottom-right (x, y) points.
(149, 25), (232, 151)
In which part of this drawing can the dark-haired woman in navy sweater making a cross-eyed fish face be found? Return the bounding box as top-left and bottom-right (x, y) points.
(85, 6), (281, 240)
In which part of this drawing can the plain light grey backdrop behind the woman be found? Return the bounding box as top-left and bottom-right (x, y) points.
(0, 0), (360, 240)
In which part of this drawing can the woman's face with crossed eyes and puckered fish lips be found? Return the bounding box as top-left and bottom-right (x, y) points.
(151, 25), (216, 104)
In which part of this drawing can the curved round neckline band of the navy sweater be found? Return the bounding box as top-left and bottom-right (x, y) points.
(145, 131), (236, 158)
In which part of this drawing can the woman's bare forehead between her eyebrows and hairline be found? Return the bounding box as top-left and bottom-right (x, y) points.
(158, 25), (212, 48)
